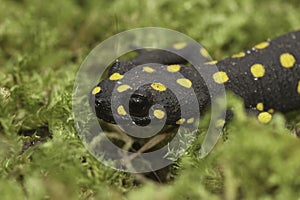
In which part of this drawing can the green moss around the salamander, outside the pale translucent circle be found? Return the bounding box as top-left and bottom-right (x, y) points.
(0, 0), (300, 199)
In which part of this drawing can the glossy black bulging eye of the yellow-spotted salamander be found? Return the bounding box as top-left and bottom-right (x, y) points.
(129, 94), (151, 117)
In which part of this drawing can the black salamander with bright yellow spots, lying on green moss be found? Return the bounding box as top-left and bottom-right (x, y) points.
(90, 31), (300, 125)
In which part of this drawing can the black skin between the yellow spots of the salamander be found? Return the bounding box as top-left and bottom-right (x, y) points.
(90, 31), (300, 126)
